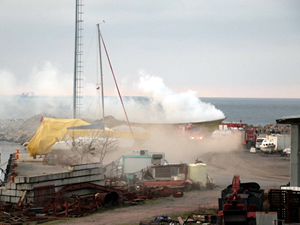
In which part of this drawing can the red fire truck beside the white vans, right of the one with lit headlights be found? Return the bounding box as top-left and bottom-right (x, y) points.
(219, 121), (257, 149)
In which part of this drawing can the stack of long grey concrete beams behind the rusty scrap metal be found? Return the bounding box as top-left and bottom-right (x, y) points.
(0, 154), (105, 203)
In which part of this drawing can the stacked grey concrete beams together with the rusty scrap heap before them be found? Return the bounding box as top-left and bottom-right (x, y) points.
(0, 153), (184, 224)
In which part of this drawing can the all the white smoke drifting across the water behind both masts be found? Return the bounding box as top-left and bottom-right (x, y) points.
(0, 67), (225, 123)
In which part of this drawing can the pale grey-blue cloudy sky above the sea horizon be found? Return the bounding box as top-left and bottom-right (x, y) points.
(0, 0), (300, 98)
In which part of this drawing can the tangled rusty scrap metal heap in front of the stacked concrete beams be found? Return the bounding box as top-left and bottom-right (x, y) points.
(0, 179), (184, 224)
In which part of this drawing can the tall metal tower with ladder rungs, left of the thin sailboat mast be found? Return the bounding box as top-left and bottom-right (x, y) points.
(73, 0), (83, 119)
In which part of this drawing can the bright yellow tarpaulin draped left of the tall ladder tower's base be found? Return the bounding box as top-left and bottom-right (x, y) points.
(27, 118), (89, 156)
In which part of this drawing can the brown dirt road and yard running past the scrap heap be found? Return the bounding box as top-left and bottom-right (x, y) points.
(57, 143), (290, 225)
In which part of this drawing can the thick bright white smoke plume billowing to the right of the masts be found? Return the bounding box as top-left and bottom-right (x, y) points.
(125, 75), (225, 123)
